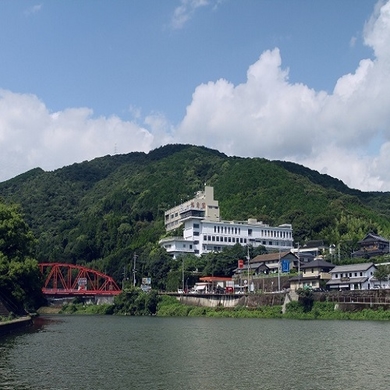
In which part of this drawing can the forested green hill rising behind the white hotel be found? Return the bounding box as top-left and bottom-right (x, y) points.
(0, 145), (390, 280)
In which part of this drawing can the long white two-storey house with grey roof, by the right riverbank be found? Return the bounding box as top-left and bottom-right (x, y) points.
(326, 263), (377, 290)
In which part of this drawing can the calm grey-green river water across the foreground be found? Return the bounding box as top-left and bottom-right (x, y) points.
(0, 316), (390, 390)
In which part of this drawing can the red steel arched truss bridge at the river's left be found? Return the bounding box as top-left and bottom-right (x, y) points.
(39, 263), (121, 297)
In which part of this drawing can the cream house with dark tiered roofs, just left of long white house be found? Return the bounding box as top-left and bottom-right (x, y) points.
(290, 258), (335, 290)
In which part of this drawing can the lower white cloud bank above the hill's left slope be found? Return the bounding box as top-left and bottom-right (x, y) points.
(0, 90), (154, 181)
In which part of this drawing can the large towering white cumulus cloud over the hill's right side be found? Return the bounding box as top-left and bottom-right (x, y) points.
(174, 2), (390, 191)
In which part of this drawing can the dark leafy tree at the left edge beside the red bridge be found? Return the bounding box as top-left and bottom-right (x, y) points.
(0, 203), (42, 311)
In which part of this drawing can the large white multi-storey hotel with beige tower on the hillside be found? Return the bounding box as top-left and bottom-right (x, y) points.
(160, 186), (293, 258)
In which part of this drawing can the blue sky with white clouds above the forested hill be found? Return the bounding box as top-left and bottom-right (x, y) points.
(0, 0), (390, 191)
